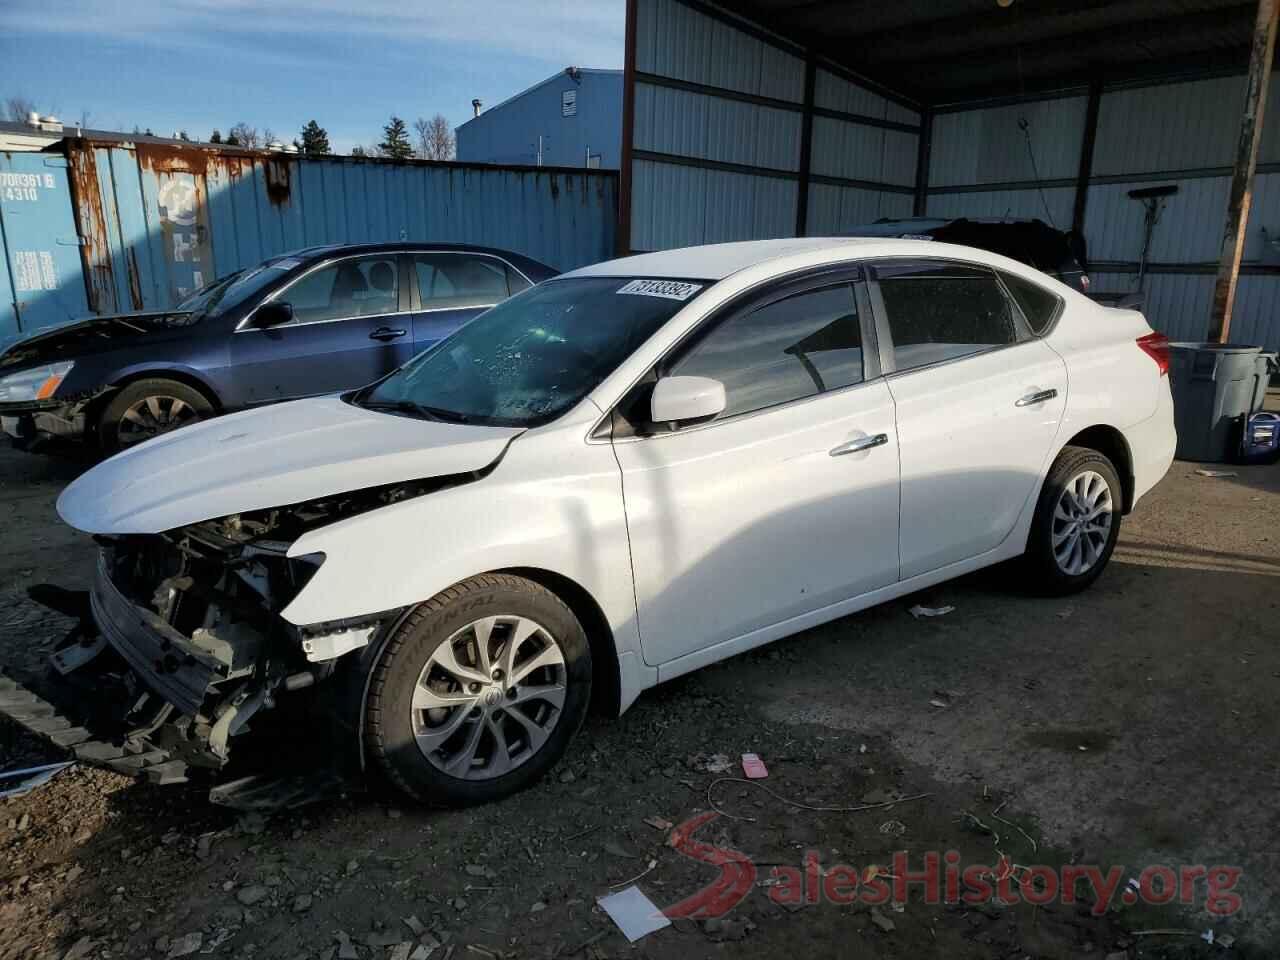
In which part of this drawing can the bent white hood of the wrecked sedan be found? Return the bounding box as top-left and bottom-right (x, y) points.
(58, 397), (521, 534)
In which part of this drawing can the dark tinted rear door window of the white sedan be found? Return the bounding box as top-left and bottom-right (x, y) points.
(878, 264), (1021, 370)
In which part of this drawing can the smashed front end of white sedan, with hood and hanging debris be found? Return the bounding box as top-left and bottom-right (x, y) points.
(0, 399), (517, 806)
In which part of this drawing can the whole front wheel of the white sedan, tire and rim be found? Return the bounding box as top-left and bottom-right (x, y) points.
(365, 573), (591, 805)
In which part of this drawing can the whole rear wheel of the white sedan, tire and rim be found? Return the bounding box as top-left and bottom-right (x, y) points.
(1023, 447), (1124, 596)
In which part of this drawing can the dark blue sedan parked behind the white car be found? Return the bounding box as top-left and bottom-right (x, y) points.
(0, 243), (556, 452)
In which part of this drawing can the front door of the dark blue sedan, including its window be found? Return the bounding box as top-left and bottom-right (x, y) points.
(230, 253), (413, 404)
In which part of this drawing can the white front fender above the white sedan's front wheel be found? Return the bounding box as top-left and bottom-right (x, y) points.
(282, 430), (640, 657)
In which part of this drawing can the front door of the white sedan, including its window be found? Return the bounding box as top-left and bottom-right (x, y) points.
(613, 274), (899, 666)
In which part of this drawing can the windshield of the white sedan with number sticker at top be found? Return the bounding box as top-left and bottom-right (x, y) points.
(352, 276), (708, 426)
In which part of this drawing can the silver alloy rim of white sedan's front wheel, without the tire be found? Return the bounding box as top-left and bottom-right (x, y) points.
(410, 616), (567, 780)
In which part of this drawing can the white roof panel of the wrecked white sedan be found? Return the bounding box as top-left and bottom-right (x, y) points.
(564, 237), (896, 280)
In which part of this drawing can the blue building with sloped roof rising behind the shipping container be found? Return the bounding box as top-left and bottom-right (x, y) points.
(457, 70), (622, 170)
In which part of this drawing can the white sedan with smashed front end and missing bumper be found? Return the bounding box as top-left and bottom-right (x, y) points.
(58, 239), (1175, 803)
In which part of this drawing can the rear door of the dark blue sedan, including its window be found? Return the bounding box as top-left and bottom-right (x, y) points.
(412, 250), (532, 351)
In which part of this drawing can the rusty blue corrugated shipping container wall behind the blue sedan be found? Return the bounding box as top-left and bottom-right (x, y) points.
(67, 141), (617, 314)
